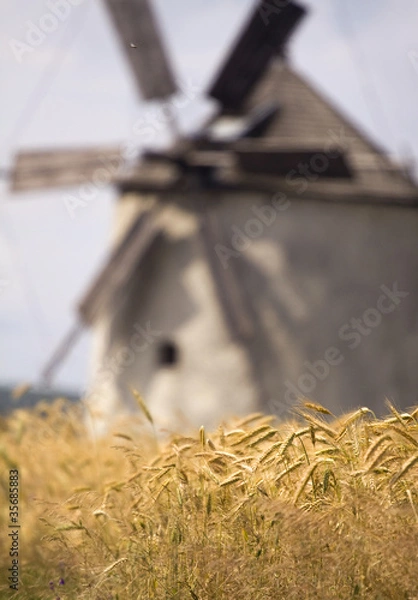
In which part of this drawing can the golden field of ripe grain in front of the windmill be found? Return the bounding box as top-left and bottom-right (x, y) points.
(0, 403), (418, 600)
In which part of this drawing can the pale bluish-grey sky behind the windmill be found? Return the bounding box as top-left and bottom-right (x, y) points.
(0, 0), (418, 391)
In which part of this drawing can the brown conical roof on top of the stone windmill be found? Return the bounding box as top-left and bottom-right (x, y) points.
(116, 60), (418, 205)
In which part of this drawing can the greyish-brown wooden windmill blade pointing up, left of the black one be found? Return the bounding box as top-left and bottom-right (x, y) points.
(105, 0), (177, 100)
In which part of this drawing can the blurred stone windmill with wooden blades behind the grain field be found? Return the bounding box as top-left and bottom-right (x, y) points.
(9, 0), (418, 427)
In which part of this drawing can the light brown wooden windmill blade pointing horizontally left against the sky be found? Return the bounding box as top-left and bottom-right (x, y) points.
(11, 147), (123, 192)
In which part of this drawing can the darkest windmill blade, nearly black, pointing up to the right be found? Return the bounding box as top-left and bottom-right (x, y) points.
(208, 0), (306, 110)
